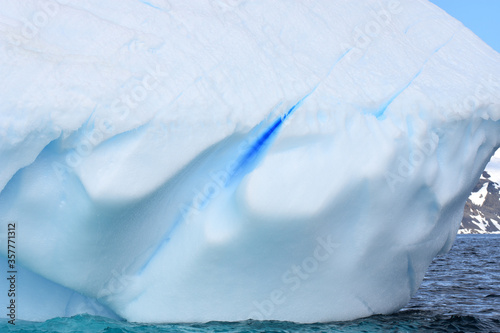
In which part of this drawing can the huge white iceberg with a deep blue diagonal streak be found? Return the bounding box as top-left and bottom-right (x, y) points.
(0, 0), (500, 323)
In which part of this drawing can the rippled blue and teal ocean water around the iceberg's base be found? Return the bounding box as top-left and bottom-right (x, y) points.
(0, 235), (500, 333)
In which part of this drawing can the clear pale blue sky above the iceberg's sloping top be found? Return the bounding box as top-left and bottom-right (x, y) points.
(430, 0), (500, 52)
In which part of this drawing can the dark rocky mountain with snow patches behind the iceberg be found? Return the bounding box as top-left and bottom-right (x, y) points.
(458, 153), (500, 234)
